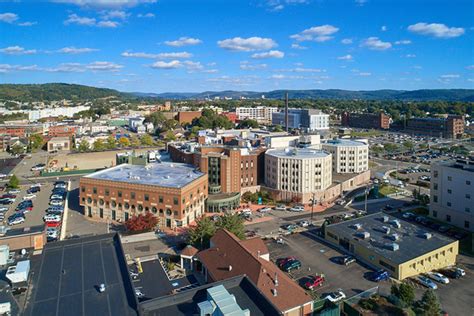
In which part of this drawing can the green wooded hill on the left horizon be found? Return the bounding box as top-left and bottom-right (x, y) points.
(0, 83), (125, 101)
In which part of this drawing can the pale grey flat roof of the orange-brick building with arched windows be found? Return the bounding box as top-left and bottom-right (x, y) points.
(84, 162), (205, 188)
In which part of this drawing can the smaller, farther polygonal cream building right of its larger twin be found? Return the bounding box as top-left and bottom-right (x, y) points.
(322, 139), (369, 173)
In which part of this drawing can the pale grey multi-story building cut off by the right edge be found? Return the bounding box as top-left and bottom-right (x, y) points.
(430, 160), (474, 232)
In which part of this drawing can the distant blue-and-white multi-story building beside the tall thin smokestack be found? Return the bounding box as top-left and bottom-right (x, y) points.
(272, 109), (329, 132)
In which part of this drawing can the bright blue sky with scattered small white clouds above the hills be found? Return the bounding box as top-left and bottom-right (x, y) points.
(0, 0), (474, 92)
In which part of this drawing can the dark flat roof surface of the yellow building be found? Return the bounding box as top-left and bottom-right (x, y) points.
(326, 212), (455, 264)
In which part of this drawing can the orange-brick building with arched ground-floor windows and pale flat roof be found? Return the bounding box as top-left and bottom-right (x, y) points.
(79, 163), (208, 228)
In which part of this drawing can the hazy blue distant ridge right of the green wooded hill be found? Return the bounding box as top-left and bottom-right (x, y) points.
(143, 89), (474, 101)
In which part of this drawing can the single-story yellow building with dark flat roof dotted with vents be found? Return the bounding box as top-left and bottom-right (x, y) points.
(325, 213), (459, 280)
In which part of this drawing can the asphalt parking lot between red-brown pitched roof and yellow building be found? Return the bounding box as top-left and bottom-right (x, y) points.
(267, 231), (384, 297)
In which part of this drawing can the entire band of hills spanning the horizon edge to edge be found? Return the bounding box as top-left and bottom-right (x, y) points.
(0, 83), (474, 102)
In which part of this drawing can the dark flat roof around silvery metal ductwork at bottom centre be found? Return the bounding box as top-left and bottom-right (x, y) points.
(140, 275), (280, 316)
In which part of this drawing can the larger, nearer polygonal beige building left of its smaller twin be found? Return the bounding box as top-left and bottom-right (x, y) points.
(265, 148), (332, 200)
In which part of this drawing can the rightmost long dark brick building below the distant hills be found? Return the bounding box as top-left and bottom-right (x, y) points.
(405, 115), (465, 138)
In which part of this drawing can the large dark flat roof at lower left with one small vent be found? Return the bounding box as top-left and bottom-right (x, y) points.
(23, 234), (138, 316)
